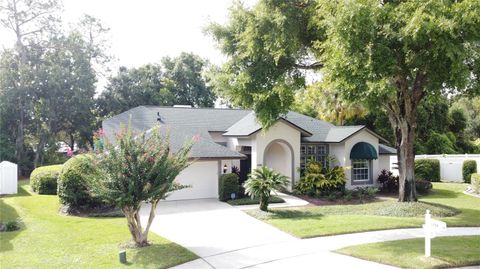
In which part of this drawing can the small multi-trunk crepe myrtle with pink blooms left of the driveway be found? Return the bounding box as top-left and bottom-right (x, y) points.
(93, 126), (196, 247)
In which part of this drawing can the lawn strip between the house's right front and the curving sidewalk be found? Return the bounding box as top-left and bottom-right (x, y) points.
(247, 183), (480, 238)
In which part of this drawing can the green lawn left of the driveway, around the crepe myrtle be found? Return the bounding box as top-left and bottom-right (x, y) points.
(0, 182), (196, 269)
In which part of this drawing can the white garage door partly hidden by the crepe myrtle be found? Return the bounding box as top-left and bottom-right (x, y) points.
(167, 161), (218, 201)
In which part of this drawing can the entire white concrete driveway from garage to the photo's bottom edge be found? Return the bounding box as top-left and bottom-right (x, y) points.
(141, 199), (400, 269)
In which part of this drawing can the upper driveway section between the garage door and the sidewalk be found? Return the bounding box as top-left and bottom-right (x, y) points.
(141, 199), (297, 257)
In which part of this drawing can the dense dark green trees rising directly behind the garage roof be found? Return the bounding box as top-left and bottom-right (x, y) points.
(97, 53), (215, 116)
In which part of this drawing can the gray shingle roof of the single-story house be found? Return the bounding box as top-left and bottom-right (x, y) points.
(103, 106), (388, 158)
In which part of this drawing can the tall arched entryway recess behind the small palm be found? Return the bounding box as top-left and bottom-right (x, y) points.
(263, 139), (295, 183)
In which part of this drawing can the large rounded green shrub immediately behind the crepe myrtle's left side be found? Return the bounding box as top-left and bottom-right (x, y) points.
(58, 154), (102, 209)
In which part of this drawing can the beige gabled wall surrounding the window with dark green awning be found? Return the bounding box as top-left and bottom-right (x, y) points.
(344, 130), (380, 189)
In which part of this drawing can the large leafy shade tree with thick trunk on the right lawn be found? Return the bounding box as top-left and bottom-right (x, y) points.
(210, 0), (480, 201)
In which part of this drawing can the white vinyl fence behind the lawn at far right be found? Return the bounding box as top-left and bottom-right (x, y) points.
(390, 154), (480, 182)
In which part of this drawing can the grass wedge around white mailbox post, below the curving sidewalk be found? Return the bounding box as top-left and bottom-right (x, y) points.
(337, 236), (480, 269)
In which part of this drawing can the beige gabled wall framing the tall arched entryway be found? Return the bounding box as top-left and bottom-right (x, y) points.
(251, 121), (301, 187)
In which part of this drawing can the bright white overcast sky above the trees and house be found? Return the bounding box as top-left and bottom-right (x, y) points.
(0, 0), (256, 69)
